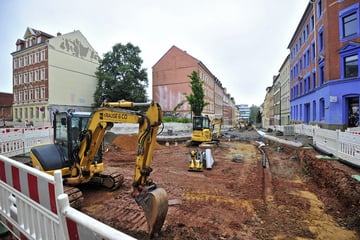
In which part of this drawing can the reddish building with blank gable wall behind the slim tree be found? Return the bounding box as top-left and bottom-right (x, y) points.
(152, 46), (237, 124)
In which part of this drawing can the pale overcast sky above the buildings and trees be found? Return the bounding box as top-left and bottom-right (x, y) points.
(0, 0), (309, 106)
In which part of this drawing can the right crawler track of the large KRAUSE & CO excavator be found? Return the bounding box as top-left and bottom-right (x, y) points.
(90, 171), (124, 191)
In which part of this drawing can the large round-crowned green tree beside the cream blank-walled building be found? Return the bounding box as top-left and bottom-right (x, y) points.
(94, 43), (149, 106)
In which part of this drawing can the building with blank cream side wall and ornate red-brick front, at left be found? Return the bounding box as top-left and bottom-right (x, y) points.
(11, 27), (100, 122)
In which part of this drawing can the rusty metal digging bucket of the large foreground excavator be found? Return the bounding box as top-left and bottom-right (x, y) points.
(135, 188), (168, 236)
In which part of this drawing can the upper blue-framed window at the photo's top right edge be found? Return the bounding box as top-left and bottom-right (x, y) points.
(339, 3), (360, 41)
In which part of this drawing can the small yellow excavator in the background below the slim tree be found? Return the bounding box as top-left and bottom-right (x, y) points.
(191, 116), (223, 145)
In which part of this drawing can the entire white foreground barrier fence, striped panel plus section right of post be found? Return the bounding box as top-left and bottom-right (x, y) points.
(0, 155), (134, 240)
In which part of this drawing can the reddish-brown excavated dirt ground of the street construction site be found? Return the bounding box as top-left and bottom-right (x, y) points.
(81, 130), (360, 240)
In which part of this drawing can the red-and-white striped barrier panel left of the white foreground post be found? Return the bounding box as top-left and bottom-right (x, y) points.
(0, 156), (65, 240)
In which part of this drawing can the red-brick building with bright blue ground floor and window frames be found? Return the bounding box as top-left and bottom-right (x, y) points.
(288, 0), (360, 129)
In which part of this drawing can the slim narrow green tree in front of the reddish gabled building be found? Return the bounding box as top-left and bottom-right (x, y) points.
(185, 71), (209, 116)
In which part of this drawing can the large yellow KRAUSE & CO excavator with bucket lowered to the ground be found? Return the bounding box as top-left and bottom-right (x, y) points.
(30, 100), (168, 236)
